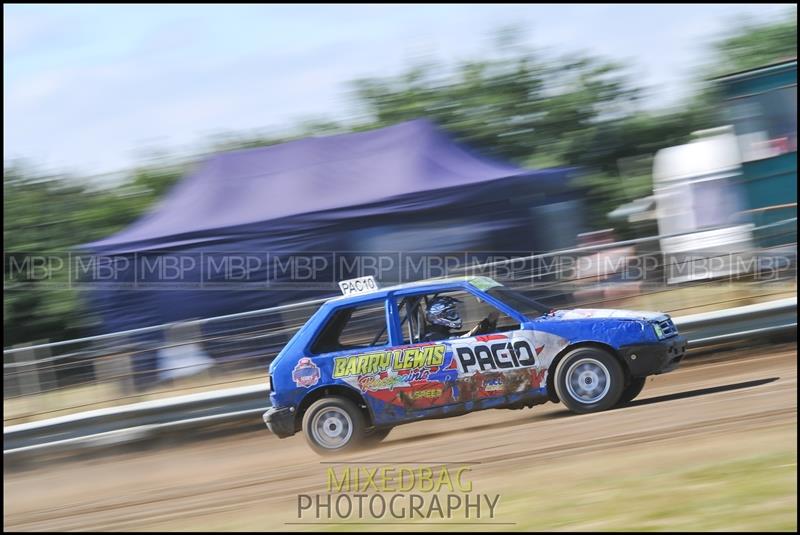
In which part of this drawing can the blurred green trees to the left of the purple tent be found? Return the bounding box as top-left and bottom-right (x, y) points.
(3, 164), (183, 346)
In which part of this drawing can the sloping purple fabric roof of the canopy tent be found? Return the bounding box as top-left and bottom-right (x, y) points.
(83, 119), (573, 253)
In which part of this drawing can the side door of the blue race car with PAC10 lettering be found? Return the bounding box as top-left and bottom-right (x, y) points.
(378, 290), (552, 417)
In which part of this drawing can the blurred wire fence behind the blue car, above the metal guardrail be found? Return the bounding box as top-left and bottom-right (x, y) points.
(3, 218), (797, 423)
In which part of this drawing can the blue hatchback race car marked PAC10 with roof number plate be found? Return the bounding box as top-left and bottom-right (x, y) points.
(264, 277), (686, 454)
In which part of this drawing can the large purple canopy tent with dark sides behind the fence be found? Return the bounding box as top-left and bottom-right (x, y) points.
(83, 120), (582, 332)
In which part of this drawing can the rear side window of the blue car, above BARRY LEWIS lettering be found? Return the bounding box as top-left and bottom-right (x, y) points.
(311, 300), (389, 355)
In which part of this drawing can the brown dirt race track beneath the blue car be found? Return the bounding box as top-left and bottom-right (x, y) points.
(3, 346), (797, 531)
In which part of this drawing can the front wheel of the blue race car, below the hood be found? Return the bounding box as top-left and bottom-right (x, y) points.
(555, 347), (625, 414)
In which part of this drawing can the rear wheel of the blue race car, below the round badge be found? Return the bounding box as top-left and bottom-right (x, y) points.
(303, 396), (367, 455)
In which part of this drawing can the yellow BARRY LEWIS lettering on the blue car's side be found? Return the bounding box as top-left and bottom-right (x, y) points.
(333, 344), (446, 380)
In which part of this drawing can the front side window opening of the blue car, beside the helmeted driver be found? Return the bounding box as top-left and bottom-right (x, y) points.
(398, 290), (519, 344)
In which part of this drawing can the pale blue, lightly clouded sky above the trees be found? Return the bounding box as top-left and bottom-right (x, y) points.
(3, 4), (789, 175)
